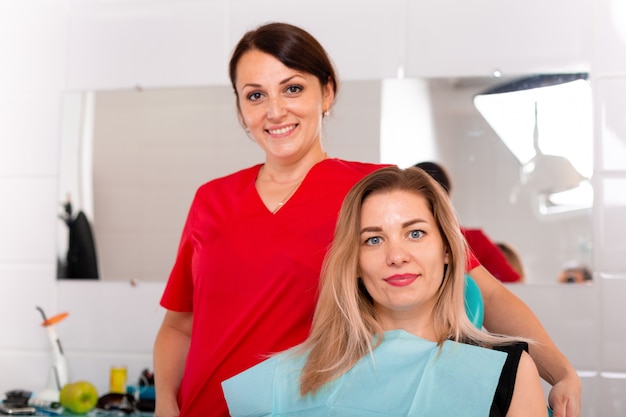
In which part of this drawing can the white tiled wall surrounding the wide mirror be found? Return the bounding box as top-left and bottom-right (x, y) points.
(0, 0), (626, 417)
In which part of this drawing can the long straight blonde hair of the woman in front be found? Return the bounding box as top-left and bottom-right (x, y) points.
(298, 167), (520, 395)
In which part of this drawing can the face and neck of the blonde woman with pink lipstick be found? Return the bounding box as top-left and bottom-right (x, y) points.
(359, 190), (448, 337)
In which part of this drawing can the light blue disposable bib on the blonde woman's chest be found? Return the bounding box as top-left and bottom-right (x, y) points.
(222, 330), (507, 417)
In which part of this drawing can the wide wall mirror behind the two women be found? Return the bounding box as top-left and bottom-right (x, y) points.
(57, 78), (591, 284)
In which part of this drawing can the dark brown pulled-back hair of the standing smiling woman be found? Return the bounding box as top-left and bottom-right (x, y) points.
(228, 22), (338, 107)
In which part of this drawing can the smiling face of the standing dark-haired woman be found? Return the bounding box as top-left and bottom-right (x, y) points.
(236, 49), (334, 161)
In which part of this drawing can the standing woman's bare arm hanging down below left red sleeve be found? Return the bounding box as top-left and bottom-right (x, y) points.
(154, 310), (193, 417)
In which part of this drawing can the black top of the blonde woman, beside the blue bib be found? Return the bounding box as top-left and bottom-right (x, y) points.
(489, 342), (528, 417)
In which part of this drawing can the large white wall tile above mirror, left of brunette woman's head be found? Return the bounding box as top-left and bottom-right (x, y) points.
(68, 2), (229, 90)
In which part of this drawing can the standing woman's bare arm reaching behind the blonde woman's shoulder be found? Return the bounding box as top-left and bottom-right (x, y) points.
(469, 266), (582, 417)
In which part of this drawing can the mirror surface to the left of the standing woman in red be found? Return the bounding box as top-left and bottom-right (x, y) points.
(58, 86), (262, 281)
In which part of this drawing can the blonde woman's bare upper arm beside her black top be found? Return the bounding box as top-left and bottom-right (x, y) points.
(506, 352), (548, 417)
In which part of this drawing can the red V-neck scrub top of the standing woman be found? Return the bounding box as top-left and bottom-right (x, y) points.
(161, 159), (382, 417)
